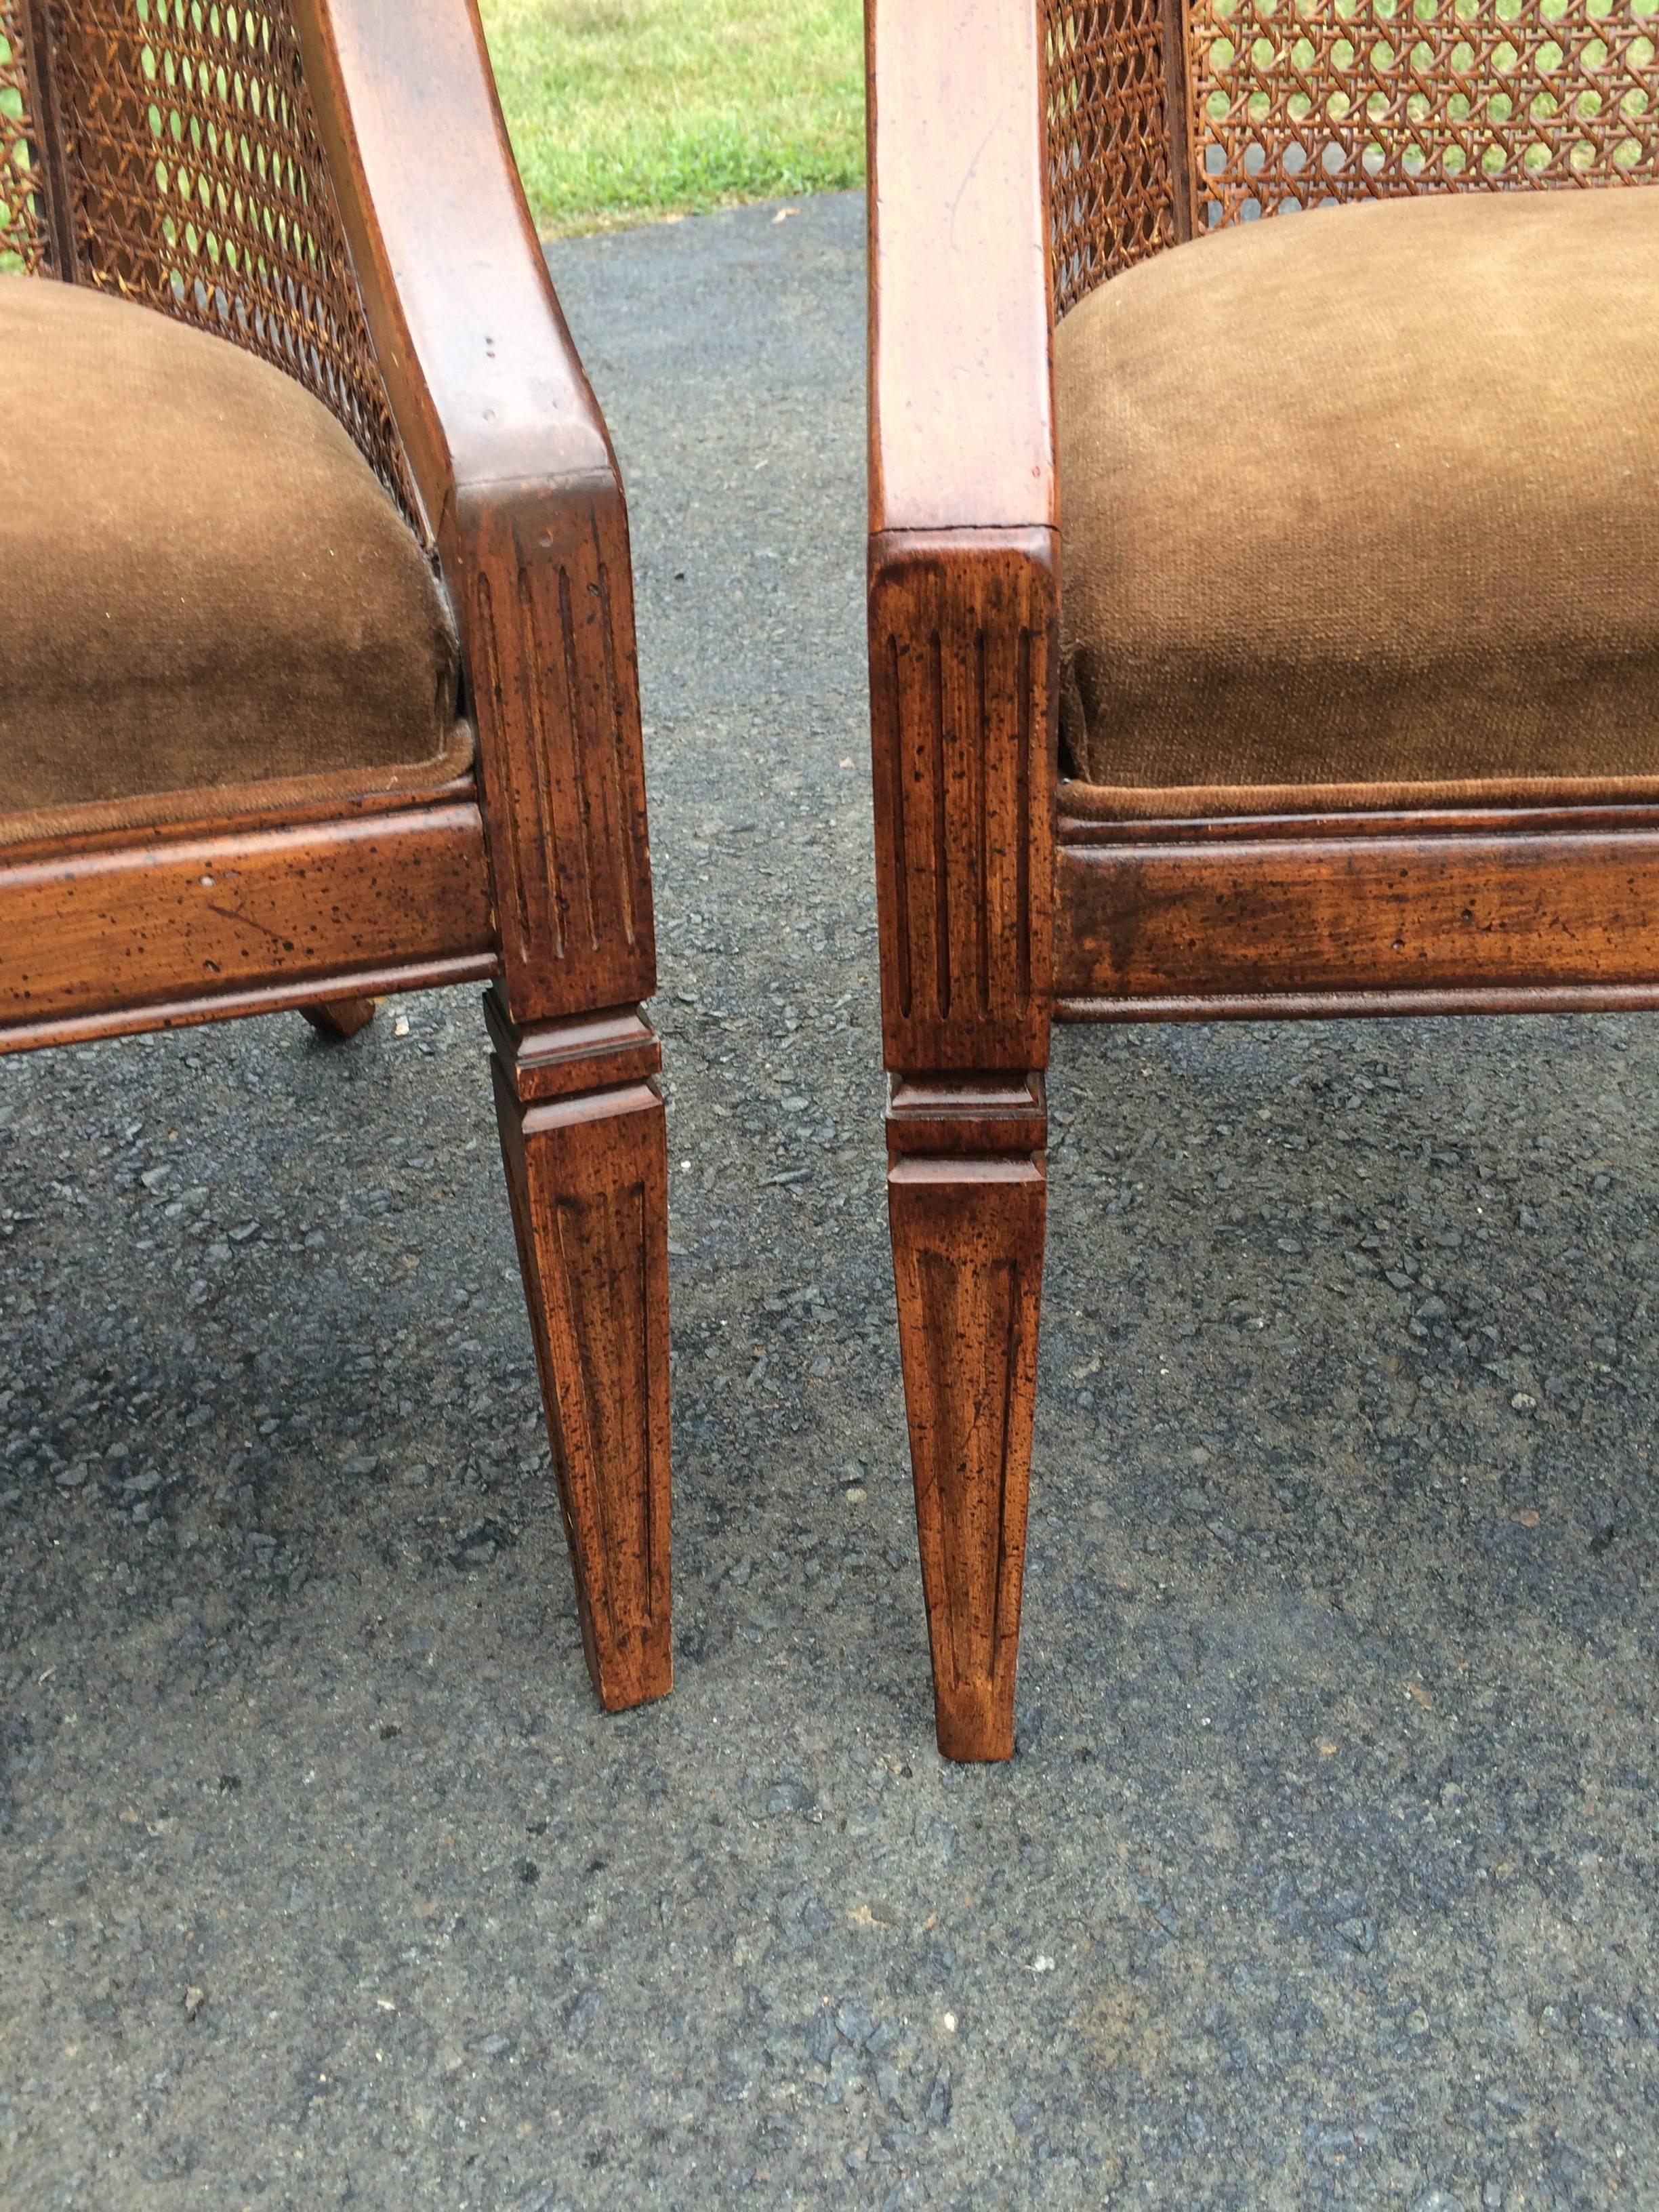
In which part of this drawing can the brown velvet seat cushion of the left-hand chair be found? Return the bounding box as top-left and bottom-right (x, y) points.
(0, 276), (471, 843)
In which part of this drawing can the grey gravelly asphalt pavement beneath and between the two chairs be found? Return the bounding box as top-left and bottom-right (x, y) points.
(0, 199), (1659, 2212)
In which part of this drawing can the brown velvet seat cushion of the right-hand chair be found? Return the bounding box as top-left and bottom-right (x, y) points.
(1055, 186), (1659, 814)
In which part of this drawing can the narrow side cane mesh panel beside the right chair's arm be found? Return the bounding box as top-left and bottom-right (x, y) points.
(1042, 0), (1174, 314)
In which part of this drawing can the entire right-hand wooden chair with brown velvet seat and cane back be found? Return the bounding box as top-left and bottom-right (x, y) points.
(867, 0), (1659, 1759)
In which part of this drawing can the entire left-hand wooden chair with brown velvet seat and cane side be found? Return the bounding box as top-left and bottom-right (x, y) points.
(0, 0), (672, 1708)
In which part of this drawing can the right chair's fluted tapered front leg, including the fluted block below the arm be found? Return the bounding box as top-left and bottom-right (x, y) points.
(869, 529), (1055, 1759)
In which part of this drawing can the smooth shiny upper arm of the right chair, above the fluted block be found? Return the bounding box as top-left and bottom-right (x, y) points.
(867, 0), (1057, 533)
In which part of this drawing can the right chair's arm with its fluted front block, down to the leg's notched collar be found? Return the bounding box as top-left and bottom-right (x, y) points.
(867, 0), (1057, 1071)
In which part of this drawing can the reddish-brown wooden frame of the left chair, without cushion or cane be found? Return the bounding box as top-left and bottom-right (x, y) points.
(0, 0), (672, 1706)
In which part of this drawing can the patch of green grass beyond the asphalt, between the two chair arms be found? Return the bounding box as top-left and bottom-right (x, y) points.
(483, 0), (865, 232)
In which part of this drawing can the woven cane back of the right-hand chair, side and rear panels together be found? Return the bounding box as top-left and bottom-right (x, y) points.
(1042, 0), (1659, 314)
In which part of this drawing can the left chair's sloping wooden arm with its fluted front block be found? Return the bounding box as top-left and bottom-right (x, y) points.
(294, 0), (655, 1024)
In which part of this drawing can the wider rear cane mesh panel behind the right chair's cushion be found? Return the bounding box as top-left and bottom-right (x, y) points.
(1188, 0), (1659, 228)
